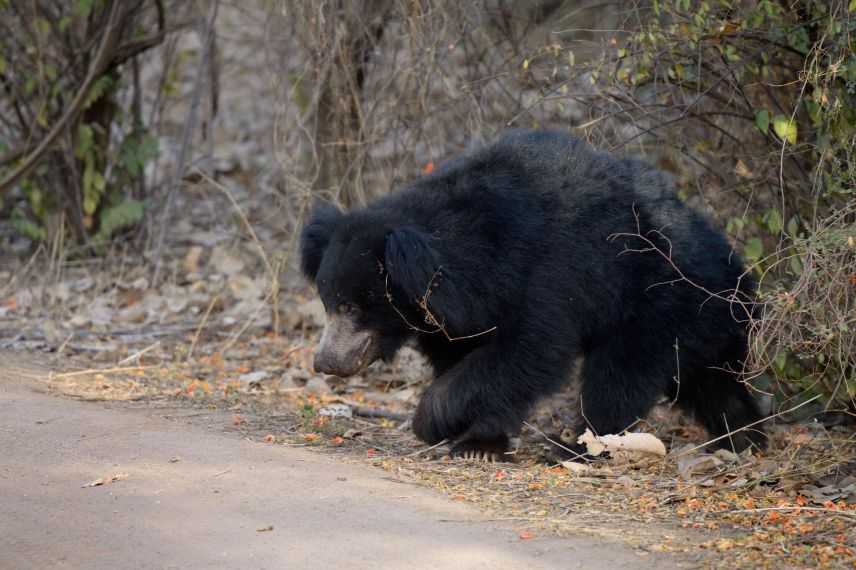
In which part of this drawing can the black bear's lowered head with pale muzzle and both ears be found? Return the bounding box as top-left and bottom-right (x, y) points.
(300, 205), (448, 376)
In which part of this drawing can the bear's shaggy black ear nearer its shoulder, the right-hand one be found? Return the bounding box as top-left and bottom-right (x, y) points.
(384, 227), (440, 301)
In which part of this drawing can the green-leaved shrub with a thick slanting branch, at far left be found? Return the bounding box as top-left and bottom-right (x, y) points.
(0, 0), (172, 245)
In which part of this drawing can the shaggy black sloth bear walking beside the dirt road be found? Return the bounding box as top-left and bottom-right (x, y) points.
(300, 127), (765, 458)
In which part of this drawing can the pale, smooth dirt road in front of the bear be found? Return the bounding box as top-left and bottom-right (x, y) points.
(0, 355), (684, 569)
